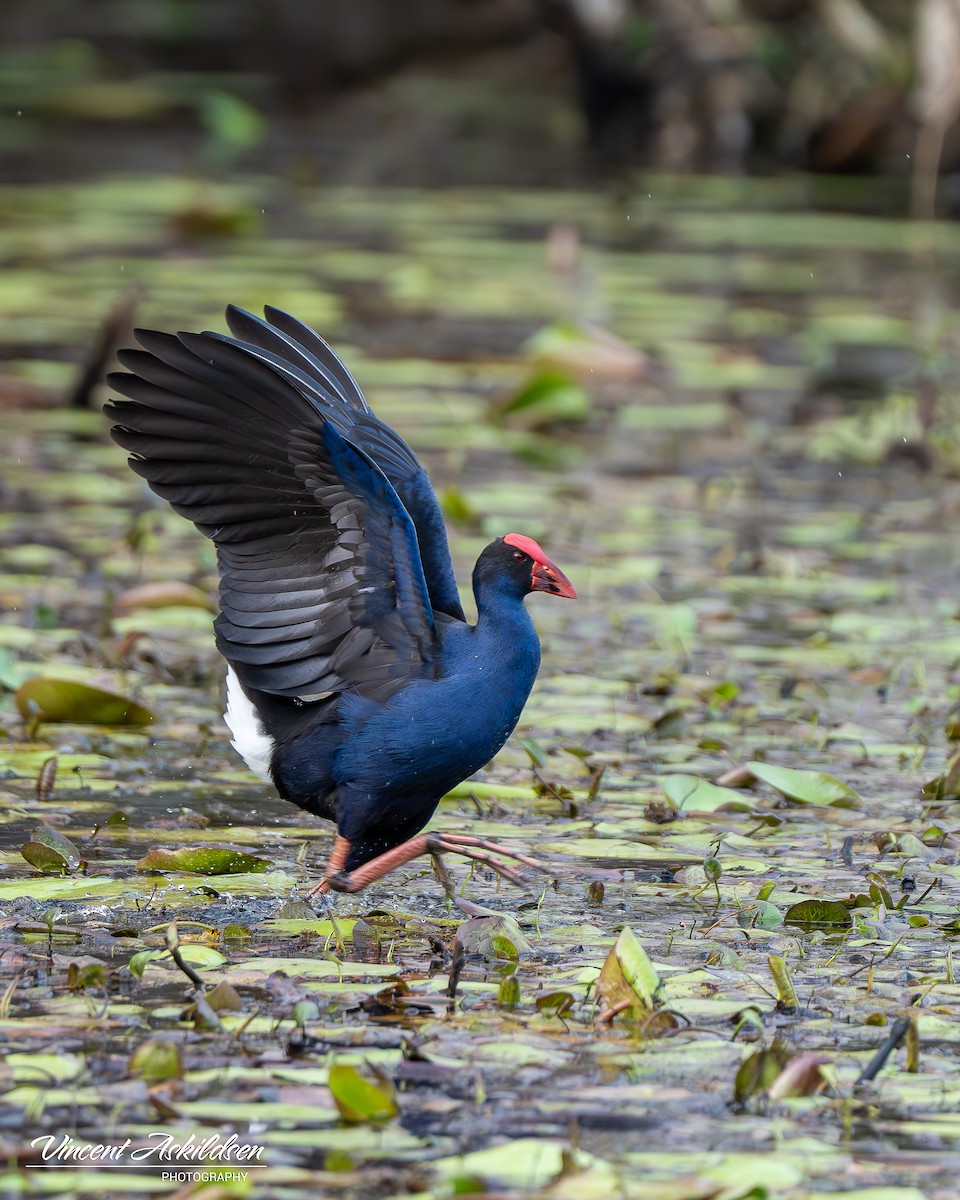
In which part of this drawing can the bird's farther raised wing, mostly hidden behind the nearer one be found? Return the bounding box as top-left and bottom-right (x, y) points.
(220, 305), (464, 620)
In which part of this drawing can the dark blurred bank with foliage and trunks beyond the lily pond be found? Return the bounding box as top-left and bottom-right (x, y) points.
(0, 0), (960, 215)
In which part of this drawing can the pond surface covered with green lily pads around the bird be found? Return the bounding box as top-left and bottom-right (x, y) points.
(0, 179), (960, 1200)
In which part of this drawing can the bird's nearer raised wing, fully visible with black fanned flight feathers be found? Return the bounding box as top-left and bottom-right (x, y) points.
(106, 330), (434, 700)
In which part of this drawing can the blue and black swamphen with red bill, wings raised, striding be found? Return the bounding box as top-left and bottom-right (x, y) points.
(104, 305), (576, 894)
